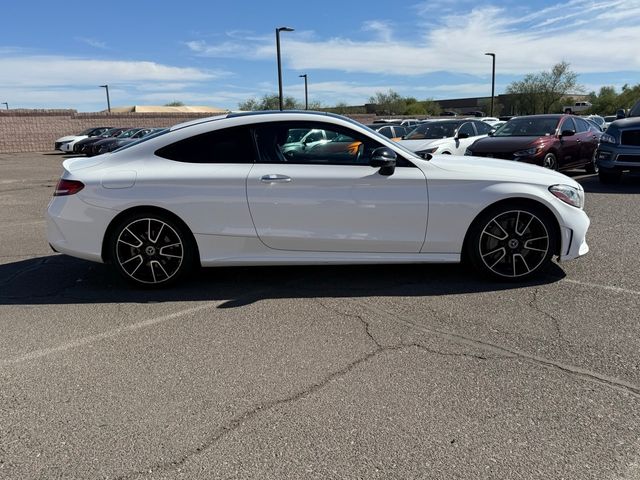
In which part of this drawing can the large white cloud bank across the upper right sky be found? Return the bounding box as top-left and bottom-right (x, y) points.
(184, 0), (640, 76)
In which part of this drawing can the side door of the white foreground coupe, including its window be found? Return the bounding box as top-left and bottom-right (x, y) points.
(247, 122), (428, 253)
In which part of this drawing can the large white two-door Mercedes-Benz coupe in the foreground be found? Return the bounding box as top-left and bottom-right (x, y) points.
(47, 111), (589, 286)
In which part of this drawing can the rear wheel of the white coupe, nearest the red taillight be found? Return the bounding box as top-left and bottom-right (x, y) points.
(108, 212), (195, 288)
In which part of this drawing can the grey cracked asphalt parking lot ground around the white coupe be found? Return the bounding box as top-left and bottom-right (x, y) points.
(0, 153), (640, 480)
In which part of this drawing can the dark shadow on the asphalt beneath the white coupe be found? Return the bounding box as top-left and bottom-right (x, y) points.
(0, 255), (565, 308)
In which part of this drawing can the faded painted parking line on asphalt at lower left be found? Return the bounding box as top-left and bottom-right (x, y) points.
(0, 302), (222, 367)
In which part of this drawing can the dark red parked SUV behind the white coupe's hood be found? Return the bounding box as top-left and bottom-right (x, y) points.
(465, 114), (602, 173)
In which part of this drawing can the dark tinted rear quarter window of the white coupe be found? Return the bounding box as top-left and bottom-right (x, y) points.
(156, 127), (256, 163)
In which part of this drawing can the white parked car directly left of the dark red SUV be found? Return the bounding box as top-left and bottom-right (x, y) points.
(398, 119), (491, 156)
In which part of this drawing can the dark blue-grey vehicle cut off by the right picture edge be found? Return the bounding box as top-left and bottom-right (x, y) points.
(596, 117), (640, 183)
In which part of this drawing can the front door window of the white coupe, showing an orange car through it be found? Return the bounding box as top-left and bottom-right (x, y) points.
(255, 122), (396, 165)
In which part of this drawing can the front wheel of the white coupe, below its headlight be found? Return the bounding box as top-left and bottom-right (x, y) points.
(465, 203), (558, 281)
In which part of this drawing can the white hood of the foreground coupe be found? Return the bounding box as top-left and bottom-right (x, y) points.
(425, 155), (582, 190)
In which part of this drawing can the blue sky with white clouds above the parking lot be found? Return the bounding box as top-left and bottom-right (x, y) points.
(0, 0), (640, 111)
